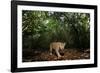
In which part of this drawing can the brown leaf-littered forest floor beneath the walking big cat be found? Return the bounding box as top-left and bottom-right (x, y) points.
(22, 49), (90, 62)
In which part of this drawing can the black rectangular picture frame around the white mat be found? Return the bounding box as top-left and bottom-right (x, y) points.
(11, 1), (97, 72)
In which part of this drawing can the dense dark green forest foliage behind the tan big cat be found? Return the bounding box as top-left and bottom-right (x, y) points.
(22, 10), (90, 49)
